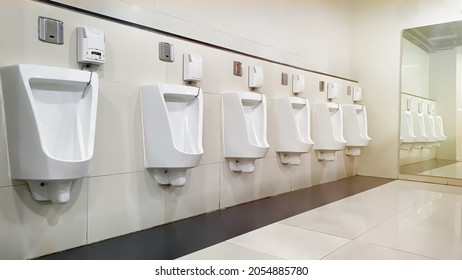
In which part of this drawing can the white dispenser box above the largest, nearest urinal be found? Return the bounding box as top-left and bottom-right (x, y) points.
(77, 27), (106, 65)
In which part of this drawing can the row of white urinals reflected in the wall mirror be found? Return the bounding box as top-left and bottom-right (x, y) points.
(400, 111), (447, 150)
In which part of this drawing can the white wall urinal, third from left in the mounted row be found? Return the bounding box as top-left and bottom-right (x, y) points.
(222, 91), (269, 173)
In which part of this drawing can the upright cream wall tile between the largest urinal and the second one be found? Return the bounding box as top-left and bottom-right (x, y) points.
(90, 81), (144, 176)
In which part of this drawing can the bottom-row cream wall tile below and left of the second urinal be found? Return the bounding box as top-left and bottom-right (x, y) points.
(88, 172), (165, 243)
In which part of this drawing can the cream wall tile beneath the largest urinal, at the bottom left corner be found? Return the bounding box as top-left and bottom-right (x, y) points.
(0, 179), (87, 259)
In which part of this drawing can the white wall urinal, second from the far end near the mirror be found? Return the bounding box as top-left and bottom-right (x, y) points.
(313, 102), (347, 161)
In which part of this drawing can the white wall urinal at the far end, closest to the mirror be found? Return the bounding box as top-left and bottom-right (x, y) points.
(342, 104), (372, 156)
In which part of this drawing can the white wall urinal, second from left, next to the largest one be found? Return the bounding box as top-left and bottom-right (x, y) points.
(140, 84), (204, 187)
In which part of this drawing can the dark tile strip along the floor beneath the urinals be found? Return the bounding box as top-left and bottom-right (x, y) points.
(38, 176), (393, 260)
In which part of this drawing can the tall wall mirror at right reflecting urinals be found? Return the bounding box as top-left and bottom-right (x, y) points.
(399, 21), (462, 179)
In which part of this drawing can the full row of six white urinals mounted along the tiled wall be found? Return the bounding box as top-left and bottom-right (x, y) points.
(0, 64), (371, 203)
